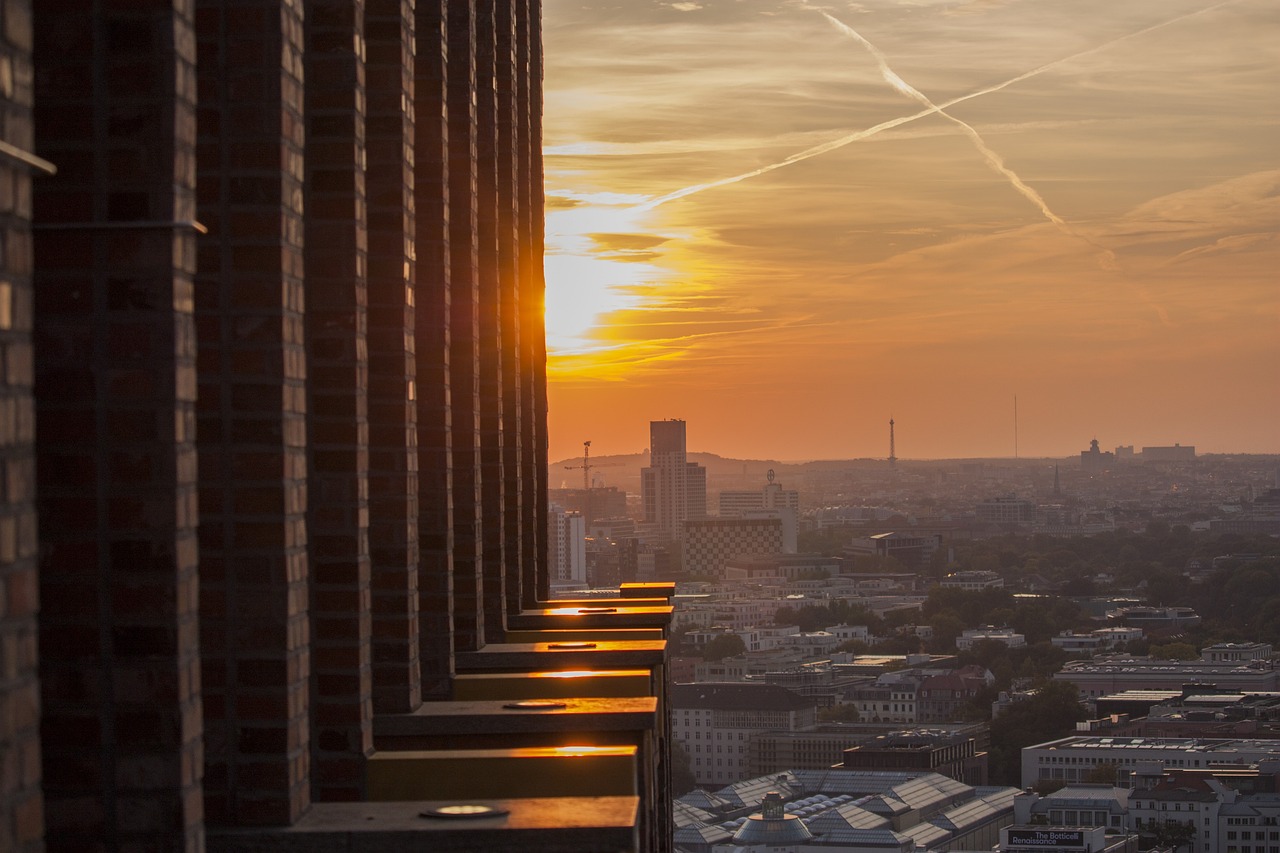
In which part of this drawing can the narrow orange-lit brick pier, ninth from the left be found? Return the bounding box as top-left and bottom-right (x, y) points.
(495, 0), (522, 612)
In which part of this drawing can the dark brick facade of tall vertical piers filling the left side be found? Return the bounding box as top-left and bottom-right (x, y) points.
(0, 0), (669, 853)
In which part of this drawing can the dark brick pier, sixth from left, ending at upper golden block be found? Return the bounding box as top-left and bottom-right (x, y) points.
(413, 0), (453, 698)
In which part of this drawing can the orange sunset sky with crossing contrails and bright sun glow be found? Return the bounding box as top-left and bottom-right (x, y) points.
(544, 0), (1280, 460)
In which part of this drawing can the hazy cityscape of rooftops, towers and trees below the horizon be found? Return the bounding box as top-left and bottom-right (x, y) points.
(549, 420), (1280, 853)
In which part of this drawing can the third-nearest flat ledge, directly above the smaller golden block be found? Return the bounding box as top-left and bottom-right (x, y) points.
(456, 640), (667, 672)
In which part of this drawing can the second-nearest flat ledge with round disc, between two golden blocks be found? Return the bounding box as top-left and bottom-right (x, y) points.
(374, 695), (658, 751)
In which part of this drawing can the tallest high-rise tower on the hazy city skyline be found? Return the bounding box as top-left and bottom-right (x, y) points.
(640, 420), (707, 540)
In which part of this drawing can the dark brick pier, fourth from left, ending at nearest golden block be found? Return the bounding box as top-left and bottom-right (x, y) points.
(305, 0), (372, 800)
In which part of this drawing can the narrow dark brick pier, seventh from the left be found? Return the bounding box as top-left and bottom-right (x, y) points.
(445, 0), (484, 652)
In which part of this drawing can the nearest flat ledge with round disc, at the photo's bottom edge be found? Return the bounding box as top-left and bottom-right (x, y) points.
(206, 797), (640, 853)
